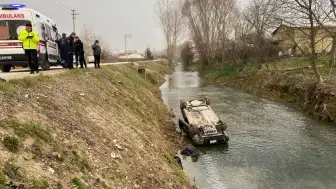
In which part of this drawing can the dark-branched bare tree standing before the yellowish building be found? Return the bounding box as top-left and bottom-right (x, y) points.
(282, 0), (328, 83)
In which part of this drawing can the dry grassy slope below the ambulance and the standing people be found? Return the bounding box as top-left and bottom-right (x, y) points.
(0, 63), (191, 189)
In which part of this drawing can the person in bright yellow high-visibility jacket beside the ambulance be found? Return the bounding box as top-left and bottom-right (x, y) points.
(18, 24), (40, 74)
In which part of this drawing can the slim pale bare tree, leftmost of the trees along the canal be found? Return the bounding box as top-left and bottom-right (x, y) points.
(154, 0), (183, 67)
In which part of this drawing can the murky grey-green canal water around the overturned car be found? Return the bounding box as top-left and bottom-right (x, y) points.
(161, 63), (336, 189)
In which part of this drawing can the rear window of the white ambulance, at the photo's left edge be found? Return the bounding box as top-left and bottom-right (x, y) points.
(0, 20), (31, 40)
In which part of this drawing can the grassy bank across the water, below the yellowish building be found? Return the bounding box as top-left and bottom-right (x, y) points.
(198, 56), (336, 121)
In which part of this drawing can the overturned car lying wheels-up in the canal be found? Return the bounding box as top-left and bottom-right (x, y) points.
(179, 98), (229, 145)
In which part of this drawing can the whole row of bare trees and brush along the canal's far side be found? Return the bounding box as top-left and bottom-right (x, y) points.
(154, 0), (336, 82)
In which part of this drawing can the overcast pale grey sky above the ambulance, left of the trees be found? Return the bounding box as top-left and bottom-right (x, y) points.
(1, 0), (248, 50)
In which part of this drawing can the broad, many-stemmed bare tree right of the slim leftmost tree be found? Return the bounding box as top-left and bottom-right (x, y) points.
(183, 0), (238, 64)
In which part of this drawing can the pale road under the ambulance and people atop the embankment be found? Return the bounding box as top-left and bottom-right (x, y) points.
(0, 60), (160, 81)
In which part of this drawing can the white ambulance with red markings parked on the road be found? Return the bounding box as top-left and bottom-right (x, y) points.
(0, 4), (60, 72)
